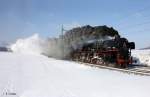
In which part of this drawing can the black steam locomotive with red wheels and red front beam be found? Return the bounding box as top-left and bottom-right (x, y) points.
(71, 36), (135, 68)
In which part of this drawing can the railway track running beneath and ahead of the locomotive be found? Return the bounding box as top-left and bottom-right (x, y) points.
(79, 62), (150, 76)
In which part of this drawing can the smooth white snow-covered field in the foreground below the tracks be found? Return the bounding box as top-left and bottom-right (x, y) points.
(0, 52), (150, 97)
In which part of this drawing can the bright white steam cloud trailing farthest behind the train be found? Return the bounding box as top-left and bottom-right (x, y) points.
(11, 34), (45, 54)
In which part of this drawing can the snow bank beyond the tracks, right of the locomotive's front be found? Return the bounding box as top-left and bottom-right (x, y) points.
(132, 50), (150, 66)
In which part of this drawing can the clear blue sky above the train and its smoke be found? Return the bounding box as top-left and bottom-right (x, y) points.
(0, 0), (150, 48)
